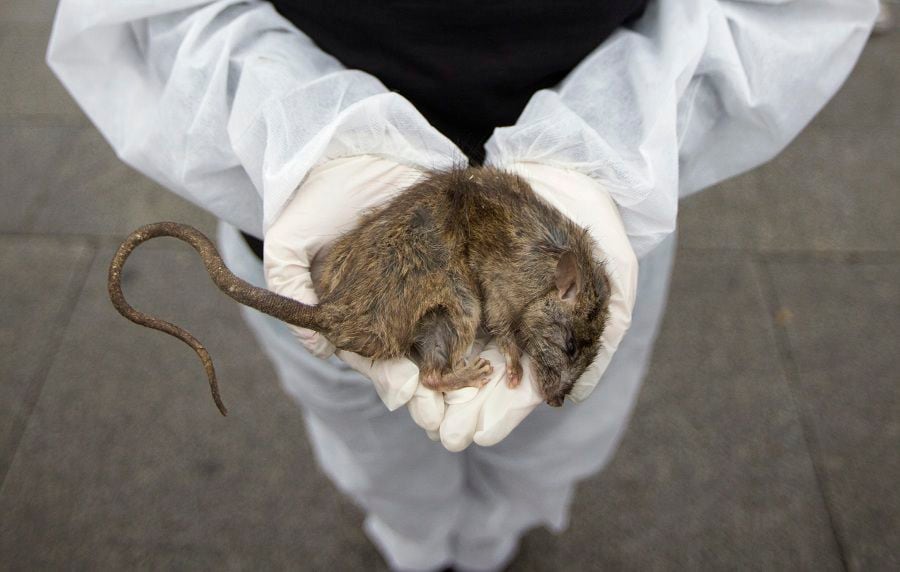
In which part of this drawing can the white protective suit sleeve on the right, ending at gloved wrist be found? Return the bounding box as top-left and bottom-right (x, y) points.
(487, 0), (877, 256)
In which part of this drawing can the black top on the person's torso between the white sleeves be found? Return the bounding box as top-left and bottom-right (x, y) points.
(273, 0), (647, 162)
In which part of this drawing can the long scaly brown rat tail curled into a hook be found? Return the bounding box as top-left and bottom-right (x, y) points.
(107, 222), (321, 415)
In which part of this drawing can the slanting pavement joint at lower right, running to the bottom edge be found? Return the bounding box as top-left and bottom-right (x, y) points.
(751, 256), (851, 572)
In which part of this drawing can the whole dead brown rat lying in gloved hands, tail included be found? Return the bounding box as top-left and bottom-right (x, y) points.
(108, 167), (610, 415)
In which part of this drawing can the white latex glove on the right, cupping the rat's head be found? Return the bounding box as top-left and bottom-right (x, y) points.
(428, 163), (638, 451)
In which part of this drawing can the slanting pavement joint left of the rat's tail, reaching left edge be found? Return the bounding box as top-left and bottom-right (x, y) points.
(0, 241), (97, 496)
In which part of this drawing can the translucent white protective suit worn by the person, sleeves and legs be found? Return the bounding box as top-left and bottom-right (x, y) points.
(48, 0), (877, 568)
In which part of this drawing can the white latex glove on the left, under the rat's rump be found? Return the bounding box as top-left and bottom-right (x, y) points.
(263, 155), (444, 430)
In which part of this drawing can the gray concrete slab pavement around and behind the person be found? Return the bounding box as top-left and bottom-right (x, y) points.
(0, 5), (900, 570)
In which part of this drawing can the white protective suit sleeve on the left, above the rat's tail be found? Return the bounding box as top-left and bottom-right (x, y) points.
(47, 0), (465, 237)
